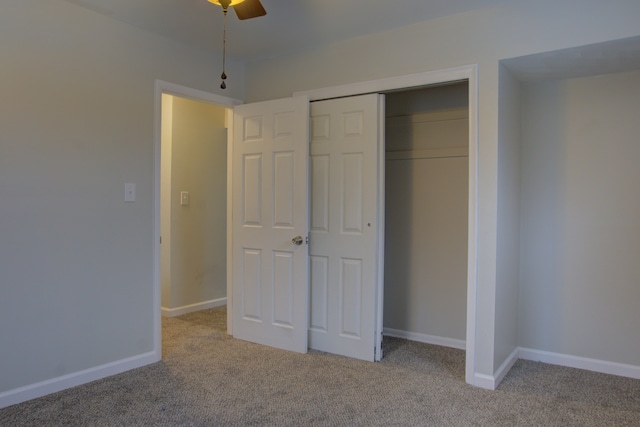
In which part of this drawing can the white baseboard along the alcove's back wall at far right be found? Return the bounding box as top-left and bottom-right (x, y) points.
(519, 347), (640, 379)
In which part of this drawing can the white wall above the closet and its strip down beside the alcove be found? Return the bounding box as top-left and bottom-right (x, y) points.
(246, 0), (640, 377)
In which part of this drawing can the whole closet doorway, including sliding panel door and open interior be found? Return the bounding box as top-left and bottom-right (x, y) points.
(302, 81), (469, 360)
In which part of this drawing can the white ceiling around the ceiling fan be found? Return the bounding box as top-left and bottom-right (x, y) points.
(65, 0), (508, 61)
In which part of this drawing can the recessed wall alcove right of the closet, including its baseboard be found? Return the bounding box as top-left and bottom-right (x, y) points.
(496, 37), (640, 378)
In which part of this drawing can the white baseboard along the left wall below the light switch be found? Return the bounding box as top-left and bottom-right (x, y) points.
(0, 351), (161, 408)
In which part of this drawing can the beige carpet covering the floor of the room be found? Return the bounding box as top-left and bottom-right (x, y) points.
(0, 307), (640, 426)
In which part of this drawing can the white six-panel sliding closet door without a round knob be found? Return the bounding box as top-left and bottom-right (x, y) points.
(309, 94), (384, 361)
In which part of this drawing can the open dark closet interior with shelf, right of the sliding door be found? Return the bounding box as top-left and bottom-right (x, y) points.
(383, 80), (469, 360)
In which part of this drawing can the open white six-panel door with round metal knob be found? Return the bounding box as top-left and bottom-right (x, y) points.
(232, 97), (309, 353)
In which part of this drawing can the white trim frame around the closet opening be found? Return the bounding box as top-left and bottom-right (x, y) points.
(294, 64), (478, 384)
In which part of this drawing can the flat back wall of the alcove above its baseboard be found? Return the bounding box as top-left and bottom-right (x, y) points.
(519, 71), (640, 366)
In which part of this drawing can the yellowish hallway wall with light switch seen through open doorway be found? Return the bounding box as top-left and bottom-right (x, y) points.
(162, 97), (227, 309)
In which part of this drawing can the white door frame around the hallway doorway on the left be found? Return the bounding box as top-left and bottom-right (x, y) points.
(152, 80), (243, 361)
